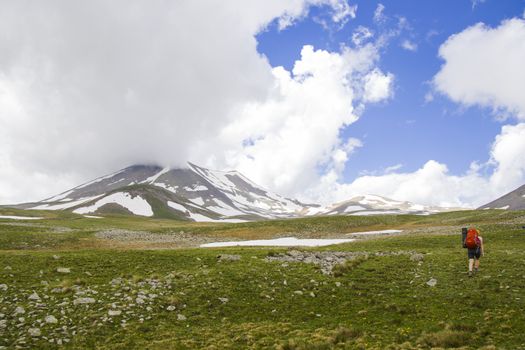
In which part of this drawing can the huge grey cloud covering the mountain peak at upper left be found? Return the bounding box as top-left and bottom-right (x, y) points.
(0, 0), (355, 203)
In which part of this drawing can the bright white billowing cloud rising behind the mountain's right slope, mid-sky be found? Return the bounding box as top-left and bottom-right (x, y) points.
(208, 44), (392, 198)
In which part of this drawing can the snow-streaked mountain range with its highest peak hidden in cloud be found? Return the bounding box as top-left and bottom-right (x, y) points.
(17, 163), (458, 222)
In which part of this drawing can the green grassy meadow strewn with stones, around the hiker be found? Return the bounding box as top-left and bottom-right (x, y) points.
(0, 209), (525, 349)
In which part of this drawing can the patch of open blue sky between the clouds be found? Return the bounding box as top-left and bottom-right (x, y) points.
(257, 0), (525, 182)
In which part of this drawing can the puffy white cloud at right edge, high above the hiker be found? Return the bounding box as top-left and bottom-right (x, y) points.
(434, 18), (525, 121)
